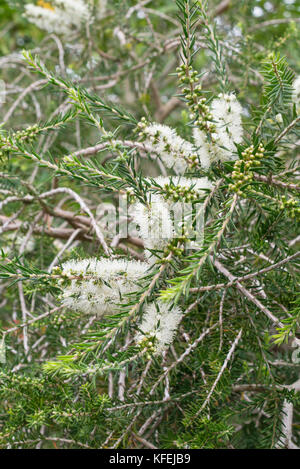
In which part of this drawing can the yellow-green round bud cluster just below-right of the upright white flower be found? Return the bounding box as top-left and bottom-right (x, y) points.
(229, 143), (265, 195)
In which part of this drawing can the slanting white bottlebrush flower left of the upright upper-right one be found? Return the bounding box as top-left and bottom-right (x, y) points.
(140, 123), (196, 174)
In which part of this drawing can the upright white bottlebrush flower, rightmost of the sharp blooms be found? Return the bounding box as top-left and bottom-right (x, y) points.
(194, 94), (243, 169)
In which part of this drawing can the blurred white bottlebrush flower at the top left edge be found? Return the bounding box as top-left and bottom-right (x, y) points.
(25, 0), (91, 35)
